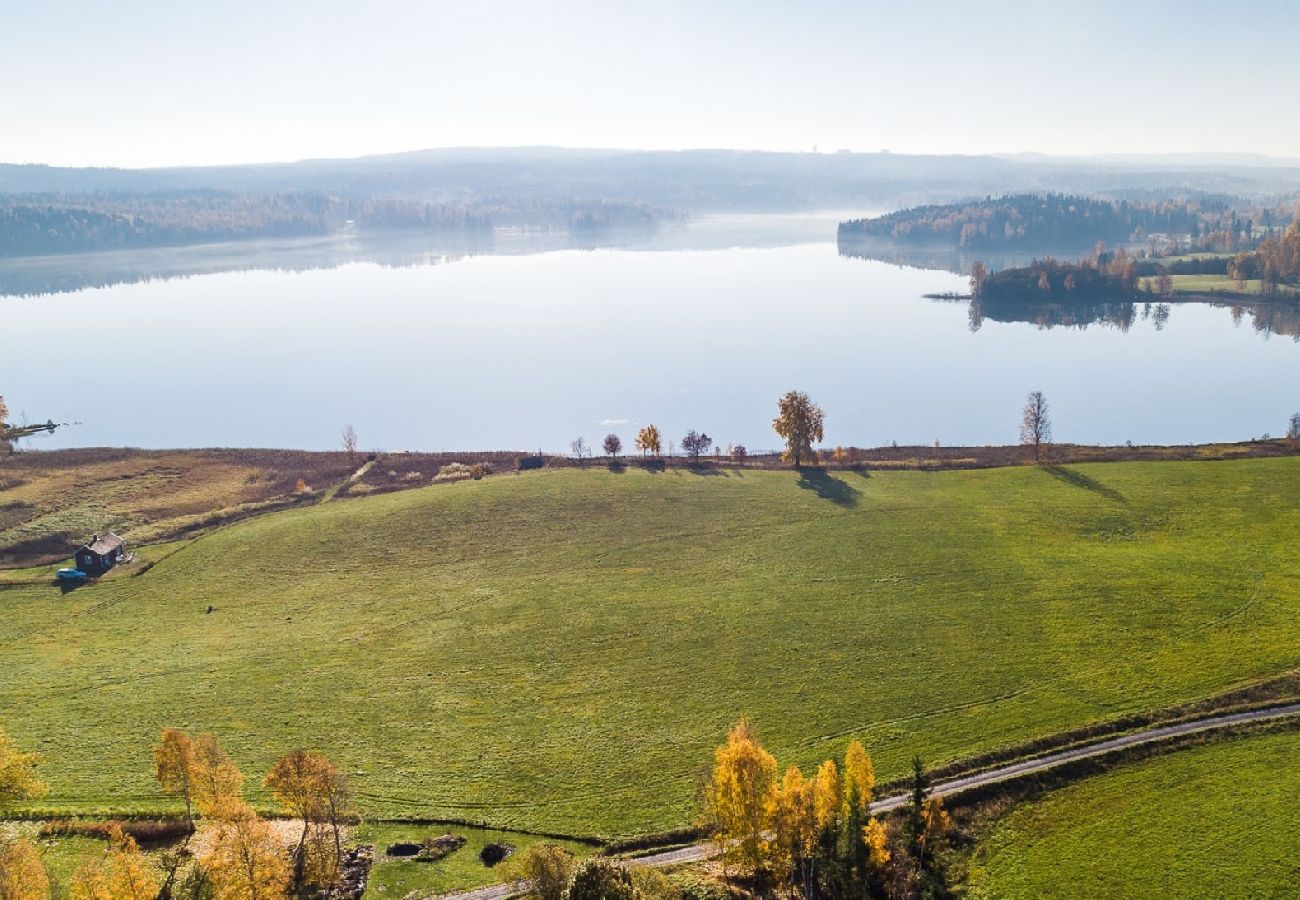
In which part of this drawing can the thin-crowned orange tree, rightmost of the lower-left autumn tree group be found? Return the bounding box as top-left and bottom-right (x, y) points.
(263, 750), (347, 887)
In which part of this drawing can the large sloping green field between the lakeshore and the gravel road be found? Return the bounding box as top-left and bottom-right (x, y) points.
(0, 458), (1300, 835)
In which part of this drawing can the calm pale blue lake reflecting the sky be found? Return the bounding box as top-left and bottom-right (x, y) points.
(0, 211), (1300, 450)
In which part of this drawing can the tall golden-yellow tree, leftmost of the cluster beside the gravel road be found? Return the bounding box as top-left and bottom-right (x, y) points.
(709, 719), (776, 871)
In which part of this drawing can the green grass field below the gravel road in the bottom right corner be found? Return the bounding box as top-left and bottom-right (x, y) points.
(970, 732), (1300, 899)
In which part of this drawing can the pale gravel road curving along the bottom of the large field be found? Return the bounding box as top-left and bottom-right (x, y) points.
(431, 702), (1300, 900)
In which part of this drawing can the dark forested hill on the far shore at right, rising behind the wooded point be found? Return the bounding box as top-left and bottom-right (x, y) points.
(840, 194), (1206, 250)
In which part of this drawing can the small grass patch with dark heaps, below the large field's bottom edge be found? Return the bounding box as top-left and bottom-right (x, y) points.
(354, 825), (592, 900)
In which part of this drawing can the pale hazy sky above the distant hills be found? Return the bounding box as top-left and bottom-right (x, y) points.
(0, 0), (1300, 166)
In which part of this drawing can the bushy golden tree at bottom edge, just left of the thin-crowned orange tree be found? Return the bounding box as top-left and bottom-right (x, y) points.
(199, 804), (290, 900)
